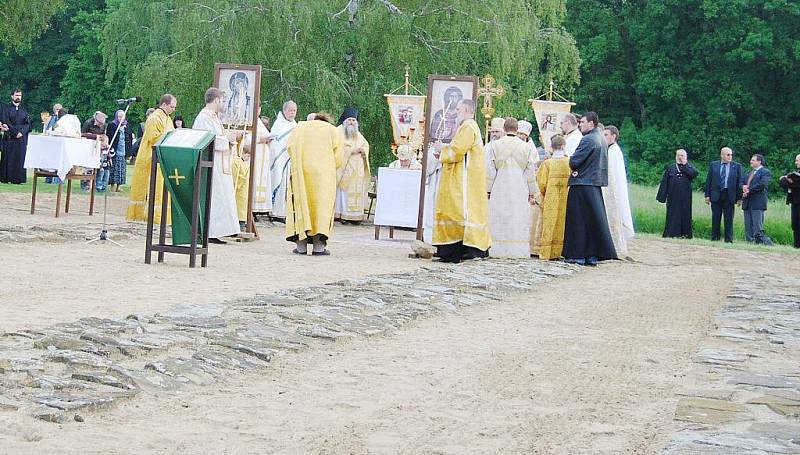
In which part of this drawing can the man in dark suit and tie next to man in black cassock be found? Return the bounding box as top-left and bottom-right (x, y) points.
(705, 147), (743, 243)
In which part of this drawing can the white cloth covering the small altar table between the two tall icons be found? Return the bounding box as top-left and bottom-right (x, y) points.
(374, 167), (422, 228)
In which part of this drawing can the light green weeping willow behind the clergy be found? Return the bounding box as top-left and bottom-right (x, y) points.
(101, 0), (580, 165)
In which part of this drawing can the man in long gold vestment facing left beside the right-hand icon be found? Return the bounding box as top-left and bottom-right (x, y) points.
(433, 100), (492, 262)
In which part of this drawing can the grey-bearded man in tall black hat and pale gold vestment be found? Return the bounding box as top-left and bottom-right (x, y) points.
(334, 108), (372, 222)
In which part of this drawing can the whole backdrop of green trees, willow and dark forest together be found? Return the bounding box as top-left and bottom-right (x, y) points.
(0, 0), (800, 192)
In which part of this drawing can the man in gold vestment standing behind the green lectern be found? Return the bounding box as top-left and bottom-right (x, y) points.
(126, 94), (178, 223)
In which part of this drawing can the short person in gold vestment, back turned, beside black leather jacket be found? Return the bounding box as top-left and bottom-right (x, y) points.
(536, 135), (572, 260)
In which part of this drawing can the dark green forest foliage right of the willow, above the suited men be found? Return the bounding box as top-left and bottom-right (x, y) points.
(567, 0), (800, 191)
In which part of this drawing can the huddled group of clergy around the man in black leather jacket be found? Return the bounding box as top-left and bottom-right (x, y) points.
(423, 104), (634, 266)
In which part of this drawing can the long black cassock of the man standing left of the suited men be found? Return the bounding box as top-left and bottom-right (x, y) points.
(656, 164), (698, 239)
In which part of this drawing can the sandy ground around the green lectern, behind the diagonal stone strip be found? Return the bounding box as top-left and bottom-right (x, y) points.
(0, 193), (420, 331)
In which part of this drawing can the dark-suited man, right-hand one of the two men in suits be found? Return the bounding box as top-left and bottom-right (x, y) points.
(742, 153), (772, 243)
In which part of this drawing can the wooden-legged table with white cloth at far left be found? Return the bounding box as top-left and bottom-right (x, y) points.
(25, 135), (100, 217)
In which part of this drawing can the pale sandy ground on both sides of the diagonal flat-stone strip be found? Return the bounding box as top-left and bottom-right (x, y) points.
(0, 191), (800, 454)
